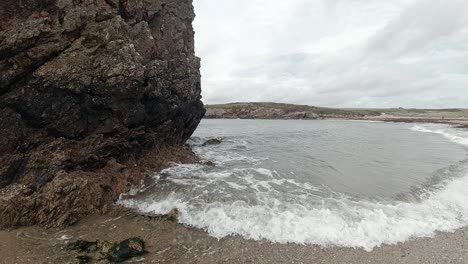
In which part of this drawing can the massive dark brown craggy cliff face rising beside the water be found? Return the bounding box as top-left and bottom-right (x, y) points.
(0, 0), (205, 227)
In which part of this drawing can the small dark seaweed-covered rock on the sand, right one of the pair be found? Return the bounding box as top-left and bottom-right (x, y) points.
(107, 237), (146, 262)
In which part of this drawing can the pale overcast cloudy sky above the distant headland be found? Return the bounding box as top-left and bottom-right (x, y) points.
(194, 0), (468, 108)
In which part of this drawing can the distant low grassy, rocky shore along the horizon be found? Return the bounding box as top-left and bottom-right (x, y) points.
(205, 103), (468, 128)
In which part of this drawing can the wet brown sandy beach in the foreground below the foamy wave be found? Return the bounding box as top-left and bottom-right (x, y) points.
(0, 213), (468, 264)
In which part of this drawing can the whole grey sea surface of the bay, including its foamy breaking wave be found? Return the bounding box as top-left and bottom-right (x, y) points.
(119, 120), (468, 250)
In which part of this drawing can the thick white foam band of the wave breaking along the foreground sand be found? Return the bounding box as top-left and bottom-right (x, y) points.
(119, 172), (468, 250)
